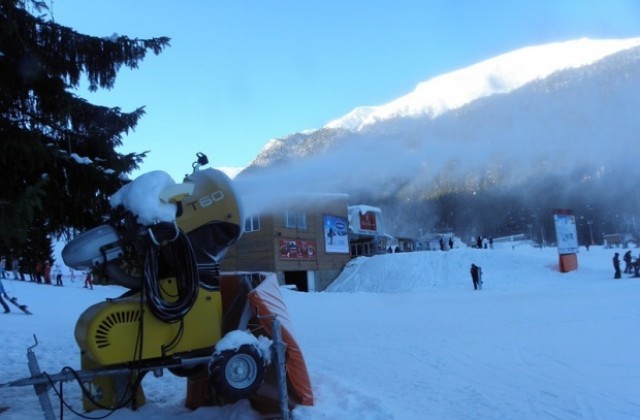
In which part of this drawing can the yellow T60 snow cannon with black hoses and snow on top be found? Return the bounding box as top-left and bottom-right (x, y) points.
(62, 155), (313, 411)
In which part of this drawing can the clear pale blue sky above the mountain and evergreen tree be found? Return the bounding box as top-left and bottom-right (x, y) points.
(51, 0), (640, 181)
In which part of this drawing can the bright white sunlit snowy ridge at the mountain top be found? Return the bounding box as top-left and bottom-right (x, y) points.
(324, 38), (640, 132)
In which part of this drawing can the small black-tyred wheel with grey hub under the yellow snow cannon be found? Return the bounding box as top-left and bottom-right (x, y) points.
(209, 345), (266, 402)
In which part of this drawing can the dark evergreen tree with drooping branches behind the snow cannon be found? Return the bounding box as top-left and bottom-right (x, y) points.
(0, 0), (169, 256)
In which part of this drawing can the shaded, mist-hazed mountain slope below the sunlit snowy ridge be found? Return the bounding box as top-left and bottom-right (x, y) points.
(238, 39), (640, 241)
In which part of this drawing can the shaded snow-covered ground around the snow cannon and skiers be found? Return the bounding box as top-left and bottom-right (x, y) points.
(0, 246), (640, 420)
